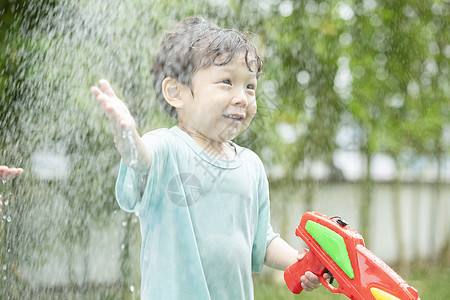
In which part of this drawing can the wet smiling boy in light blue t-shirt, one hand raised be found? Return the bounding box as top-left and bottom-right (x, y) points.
(92, 17), (319, 300)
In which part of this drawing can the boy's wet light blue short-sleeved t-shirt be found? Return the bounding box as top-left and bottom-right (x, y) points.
(116, 126), (277, 300)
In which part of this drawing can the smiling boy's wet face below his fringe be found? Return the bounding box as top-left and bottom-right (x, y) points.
(177, 54), (257, 143)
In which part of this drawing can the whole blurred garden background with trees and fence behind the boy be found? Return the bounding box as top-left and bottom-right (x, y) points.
(0, 0), (450, 299)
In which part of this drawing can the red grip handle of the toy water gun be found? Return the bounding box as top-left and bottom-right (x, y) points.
(284, 251), (325, 294)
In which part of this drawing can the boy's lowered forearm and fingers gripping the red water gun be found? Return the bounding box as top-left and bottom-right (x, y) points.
(264, 237), (320, 292)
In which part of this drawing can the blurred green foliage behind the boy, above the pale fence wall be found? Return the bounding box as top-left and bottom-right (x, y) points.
(0, 0), (450, 296)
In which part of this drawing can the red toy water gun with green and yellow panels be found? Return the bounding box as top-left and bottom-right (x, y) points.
(284, 212), (419, 300)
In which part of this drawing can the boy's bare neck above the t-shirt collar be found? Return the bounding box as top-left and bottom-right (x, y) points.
(178, 124), (236, 160)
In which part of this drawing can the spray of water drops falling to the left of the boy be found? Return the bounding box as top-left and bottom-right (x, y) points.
(0, 0), (250, 299)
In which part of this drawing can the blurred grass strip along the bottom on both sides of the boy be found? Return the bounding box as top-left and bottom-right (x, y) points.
(4, 263), (450, 300)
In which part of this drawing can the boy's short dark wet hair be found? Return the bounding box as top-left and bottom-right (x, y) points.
(151, 17), (263, 118)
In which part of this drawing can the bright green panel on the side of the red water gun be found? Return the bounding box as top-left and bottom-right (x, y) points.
(305, 221), (355, 279)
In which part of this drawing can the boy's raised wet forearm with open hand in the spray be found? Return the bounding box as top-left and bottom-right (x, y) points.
(91, 79), (151, 172)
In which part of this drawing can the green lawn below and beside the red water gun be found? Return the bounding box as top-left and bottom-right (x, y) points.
(254, 264), (450, 300)
